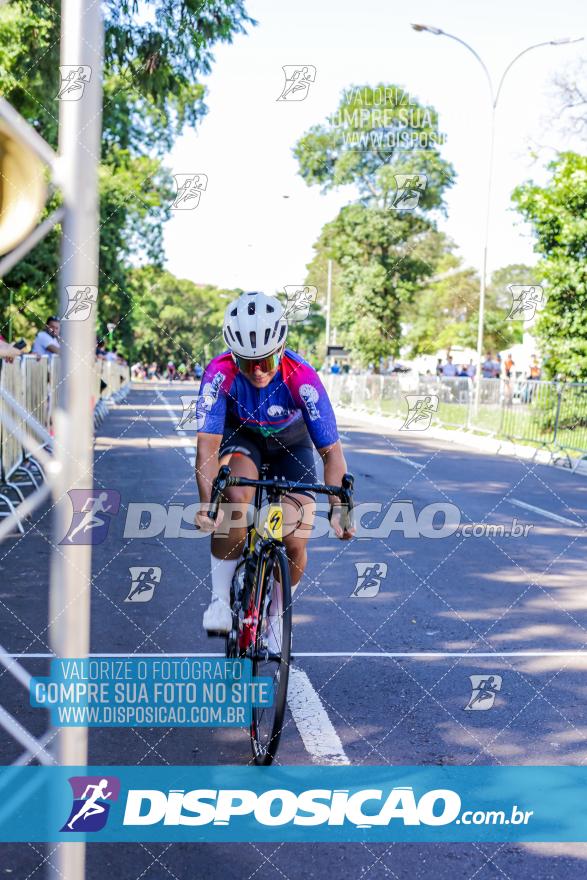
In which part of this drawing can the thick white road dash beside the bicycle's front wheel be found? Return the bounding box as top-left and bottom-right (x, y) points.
(287, 666), (350, 764)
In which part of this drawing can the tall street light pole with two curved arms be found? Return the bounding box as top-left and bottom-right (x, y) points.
(412, 24), (583, 412)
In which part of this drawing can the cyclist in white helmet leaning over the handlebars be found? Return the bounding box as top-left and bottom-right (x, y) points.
(195, 292), (354, 632)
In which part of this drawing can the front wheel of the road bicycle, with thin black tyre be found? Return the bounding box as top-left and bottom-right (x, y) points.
(250, 548), (292, 765)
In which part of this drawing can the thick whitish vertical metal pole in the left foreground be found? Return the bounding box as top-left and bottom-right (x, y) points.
(49, 0), (103, 880)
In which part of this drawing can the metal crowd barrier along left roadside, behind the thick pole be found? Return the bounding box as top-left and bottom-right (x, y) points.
(0, 355), (130, 539)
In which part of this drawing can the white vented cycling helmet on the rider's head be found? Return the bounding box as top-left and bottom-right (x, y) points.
(222, 291), (287, 359)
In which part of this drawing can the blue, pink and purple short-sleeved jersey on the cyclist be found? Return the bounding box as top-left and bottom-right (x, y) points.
(196, 348), (338, 449)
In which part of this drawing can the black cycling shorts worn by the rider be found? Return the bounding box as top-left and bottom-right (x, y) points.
(218, 425), (318, 498)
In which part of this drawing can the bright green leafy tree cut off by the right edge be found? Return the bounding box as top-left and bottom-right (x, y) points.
(513, 152), (587, 380)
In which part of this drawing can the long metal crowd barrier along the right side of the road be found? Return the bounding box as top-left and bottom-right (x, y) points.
(323, 373), (587, 465)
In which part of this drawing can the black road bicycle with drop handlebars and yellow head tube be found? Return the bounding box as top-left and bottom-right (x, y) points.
(208, 465), (354, 765)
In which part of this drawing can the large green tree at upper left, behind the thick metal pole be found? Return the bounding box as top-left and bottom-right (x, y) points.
(0, 0), (253, 350)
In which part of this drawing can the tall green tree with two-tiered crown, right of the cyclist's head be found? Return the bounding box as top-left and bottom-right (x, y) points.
(294, 84), (454, 363)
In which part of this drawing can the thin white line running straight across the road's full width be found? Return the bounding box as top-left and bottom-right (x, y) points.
(9, 651), (587, 661)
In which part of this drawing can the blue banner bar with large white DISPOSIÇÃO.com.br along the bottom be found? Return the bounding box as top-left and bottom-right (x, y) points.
(0, 766), (587, 843)
